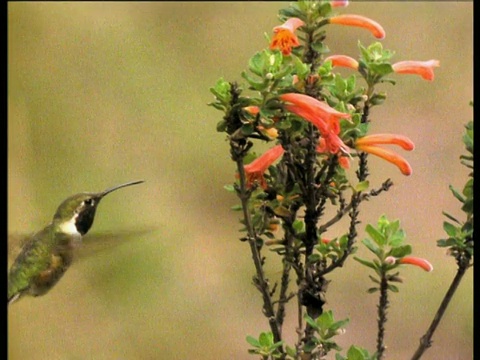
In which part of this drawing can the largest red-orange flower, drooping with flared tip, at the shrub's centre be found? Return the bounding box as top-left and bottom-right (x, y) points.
(280, 93), (351, 154)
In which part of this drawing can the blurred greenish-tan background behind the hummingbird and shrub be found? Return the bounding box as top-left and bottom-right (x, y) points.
(8, 1), (473, 360)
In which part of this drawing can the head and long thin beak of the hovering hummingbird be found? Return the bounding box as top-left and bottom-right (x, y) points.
(53, 180), (144, 235)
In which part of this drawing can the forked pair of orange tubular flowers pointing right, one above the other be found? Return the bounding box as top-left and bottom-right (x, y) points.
(355, 134), (415, 175)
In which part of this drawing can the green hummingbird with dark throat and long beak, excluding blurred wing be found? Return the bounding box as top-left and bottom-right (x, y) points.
(8, 180), (144, 305)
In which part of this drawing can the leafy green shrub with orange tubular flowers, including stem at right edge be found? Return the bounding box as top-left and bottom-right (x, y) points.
(210, 1), (473, 359)
